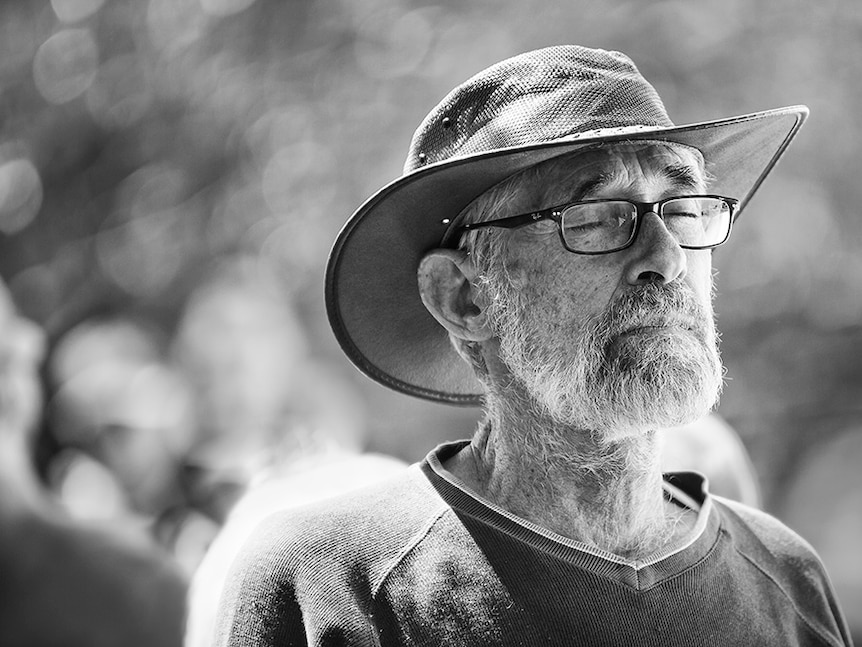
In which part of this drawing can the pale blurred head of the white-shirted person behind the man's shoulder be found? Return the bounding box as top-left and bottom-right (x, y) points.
(173, 258), (364, 492)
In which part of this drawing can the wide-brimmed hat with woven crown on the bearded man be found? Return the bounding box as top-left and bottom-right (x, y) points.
(326, 46), (808, 405)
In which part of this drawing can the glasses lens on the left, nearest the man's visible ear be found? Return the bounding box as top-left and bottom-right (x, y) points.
(560, 200), (637, 252)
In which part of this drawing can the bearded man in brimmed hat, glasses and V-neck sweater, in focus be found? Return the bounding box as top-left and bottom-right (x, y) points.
(214, 47), (849, 646)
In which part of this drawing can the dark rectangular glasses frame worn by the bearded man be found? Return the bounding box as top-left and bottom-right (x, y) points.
(452, 193), (739, 256)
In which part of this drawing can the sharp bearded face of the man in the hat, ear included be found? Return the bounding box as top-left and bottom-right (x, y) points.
(420, 142), (722, 440)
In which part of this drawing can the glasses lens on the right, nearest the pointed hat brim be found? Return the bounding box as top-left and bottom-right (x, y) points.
(661, 197), (730, 247)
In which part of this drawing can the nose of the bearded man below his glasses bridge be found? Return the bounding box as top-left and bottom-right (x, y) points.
(626, 212), (688, 285)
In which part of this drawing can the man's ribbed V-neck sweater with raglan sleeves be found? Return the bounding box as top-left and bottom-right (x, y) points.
(218, 444), (851, 647)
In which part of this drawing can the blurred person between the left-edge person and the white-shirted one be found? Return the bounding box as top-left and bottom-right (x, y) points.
(46, 314), (224, 575)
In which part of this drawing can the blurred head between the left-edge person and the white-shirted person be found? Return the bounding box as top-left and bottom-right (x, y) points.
(48, 317), (194, 512)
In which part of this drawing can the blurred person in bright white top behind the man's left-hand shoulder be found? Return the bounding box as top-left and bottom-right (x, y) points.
(179, 258), (405, 647)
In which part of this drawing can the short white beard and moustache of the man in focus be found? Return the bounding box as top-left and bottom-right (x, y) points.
(486, 272), (723, 442)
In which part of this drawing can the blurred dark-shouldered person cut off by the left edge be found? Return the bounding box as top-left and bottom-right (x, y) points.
(0, 288), (187, 647)
